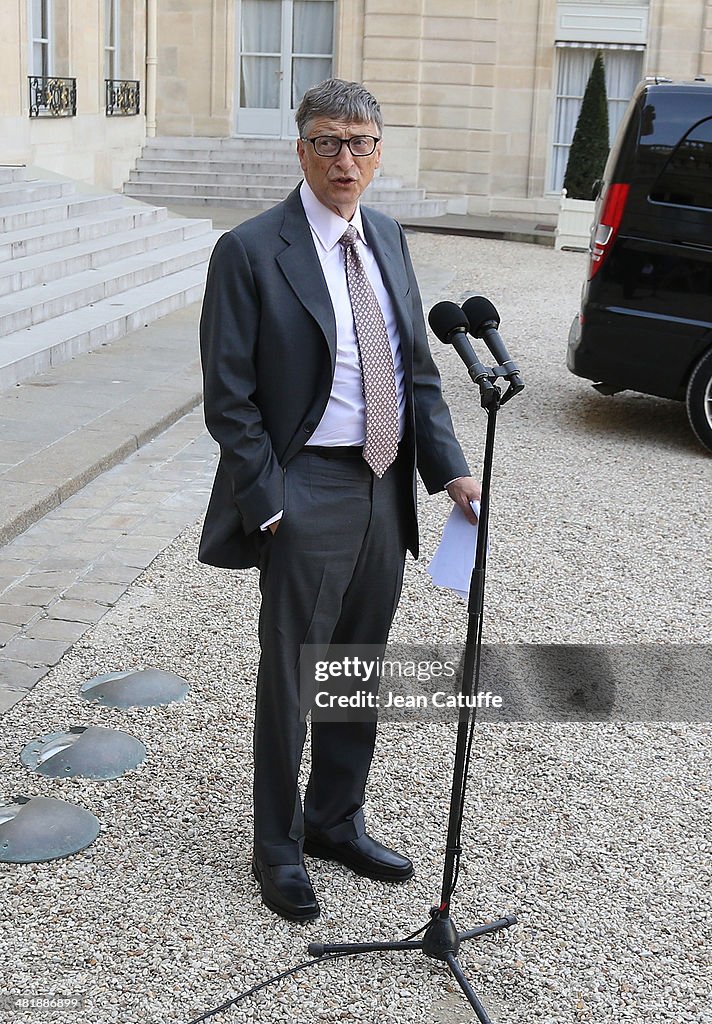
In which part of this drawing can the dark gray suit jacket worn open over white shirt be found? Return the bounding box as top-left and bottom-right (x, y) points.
(199, 188), (469, 568)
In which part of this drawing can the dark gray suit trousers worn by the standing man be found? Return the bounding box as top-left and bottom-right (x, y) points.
(253, 446), (412, 864)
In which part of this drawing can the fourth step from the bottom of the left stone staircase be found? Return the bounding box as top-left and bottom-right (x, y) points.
(0, 202), (168, 260)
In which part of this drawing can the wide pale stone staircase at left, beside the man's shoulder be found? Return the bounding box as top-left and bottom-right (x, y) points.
(0, 166), (220, 388)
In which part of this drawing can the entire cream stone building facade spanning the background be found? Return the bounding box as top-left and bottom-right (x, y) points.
(0, 0), (712, 216)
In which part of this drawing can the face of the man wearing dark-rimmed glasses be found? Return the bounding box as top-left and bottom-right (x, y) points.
(297, 118), (381, 220)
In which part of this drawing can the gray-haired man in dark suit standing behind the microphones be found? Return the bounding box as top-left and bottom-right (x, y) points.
(199, 79), (479, 921)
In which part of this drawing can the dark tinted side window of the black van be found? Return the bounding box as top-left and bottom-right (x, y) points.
(651, 118), (712, 210)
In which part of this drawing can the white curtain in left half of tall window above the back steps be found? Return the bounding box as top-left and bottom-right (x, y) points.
(240, 0), (282, 110)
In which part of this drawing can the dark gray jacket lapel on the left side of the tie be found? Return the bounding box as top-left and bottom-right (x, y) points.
(277, 186), (336, 370)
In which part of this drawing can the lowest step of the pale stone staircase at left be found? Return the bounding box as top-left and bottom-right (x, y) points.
(0, 260), (220, 388)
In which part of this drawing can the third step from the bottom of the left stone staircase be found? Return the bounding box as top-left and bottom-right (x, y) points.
(0, 218), (212, 295)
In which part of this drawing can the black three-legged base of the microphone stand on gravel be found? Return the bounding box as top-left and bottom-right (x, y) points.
(307, 913), (516, 1024)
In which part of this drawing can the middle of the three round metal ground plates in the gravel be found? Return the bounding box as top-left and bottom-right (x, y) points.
(19, 726), (145, 779)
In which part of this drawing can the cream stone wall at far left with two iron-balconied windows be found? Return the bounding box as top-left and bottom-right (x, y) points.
(0, 0), (146, 188)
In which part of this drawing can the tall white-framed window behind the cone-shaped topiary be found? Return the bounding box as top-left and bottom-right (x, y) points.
(548, 43), (643, 193)
